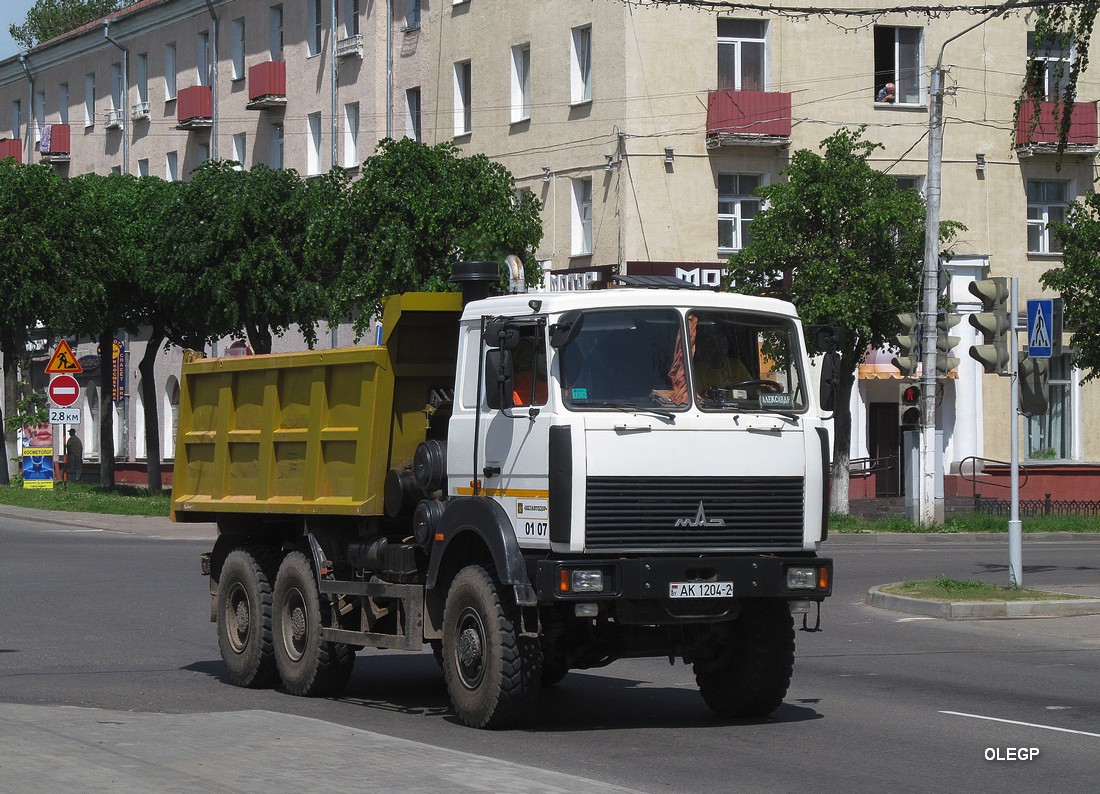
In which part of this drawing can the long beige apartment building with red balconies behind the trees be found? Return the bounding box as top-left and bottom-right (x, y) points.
(0, 0), (1100, 495)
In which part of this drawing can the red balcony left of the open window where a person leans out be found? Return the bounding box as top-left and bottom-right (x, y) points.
(706, 91), (791, 148)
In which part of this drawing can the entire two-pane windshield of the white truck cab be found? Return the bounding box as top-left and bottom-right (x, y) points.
(561, 309), (806, 412)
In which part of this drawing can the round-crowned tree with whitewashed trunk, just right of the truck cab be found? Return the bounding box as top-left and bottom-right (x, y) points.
(728, 129), (963, 512)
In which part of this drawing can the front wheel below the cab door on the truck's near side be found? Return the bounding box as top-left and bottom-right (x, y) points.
(443, 565), (541, 728)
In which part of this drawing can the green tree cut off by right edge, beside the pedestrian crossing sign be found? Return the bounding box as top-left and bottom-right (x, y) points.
(1040, 192), (1100, 382)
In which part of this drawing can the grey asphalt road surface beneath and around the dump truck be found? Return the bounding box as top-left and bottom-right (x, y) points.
(0, 507), (1100, 793)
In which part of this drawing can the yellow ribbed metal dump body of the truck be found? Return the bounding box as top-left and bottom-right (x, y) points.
(172, 293), (462, 521)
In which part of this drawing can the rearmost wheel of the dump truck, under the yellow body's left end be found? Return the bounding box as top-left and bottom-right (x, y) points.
(215, 547), (278, 688)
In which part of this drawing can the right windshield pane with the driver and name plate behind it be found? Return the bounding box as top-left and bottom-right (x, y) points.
(688, 309), (806, 411)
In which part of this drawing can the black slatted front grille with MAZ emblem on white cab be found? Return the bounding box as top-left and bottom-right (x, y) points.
(585, 477), (803, 551)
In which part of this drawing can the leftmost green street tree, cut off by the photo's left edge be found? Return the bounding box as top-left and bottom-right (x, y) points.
(0, 158), (65, 484)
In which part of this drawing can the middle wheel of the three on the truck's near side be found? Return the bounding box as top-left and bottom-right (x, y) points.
(272, 551), (355, 697)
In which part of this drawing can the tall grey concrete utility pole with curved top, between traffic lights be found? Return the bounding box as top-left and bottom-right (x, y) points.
(917, 0), (1019, 527)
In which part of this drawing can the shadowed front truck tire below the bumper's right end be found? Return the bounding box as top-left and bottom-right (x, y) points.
(695, 599), (794, 717)
